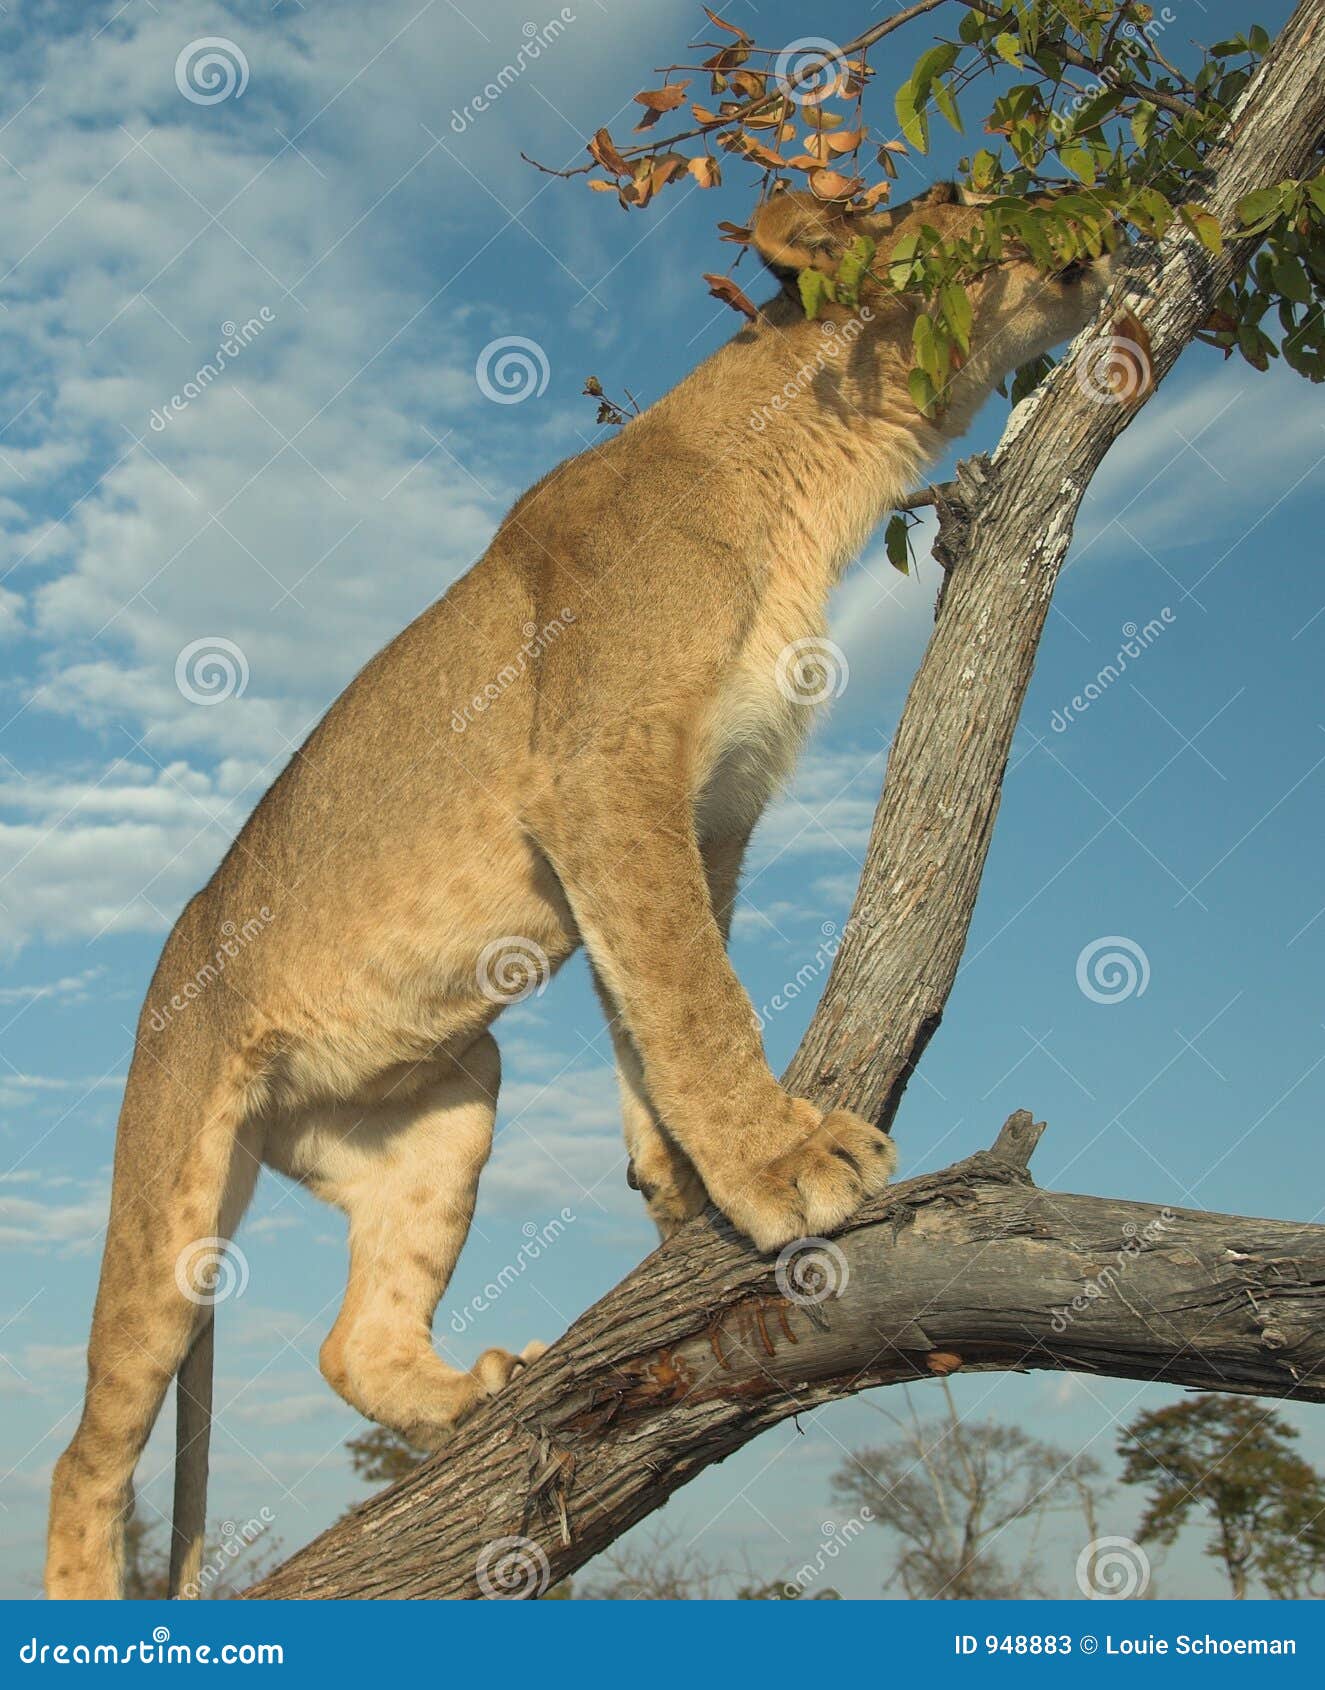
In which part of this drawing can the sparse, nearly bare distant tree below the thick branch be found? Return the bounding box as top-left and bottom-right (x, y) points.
(832, 1384), (1102, 1600)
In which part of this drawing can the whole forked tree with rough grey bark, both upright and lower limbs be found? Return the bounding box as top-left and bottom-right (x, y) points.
(248, 0), (1325, 1599)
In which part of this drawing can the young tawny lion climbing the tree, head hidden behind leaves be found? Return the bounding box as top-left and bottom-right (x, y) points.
(46, 186), (1109, 1597)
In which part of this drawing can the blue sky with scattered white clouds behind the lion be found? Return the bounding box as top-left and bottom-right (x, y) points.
(0, 0), (1325, 1595)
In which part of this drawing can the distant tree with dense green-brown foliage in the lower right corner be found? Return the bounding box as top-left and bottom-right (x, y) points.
(1119, 1396), (1325, 1600)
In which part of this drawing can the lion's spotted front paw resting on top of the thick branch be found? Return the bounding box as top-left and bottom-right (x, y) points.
(720, 1105), (897, 1251)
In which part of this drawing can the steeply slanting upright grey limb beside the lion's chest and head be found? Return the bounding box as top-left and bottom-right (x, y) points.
(788, 0), (1325, 1122)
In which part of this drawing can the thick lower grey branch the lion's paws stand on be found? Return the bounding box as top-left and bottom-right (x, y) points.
(248, 1114), (1325, 1600)
